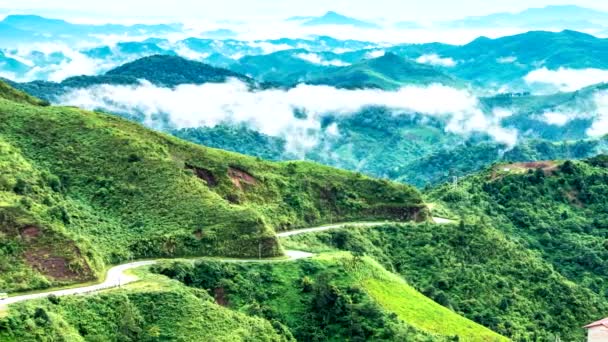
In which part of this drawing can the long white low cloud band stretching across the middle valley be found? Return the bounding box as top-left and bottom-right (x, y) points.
(58, 80), (517, 153)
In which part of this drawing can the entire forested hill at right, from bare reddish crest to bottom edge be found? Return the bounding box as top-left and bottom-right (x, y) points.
(285, 156), (608, 341)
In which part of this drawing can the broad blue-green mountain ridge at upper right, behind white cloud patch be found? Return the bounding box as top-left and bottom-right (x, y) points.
(388, 30), (608, 91)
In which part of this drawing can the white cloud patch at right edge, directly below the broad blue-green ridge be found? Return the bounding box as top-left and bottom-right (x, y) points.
(524, 67), (608, 91)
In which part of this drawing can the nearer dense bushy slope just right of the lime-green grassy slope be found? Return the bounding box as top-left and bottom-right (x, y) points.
(285, 222), (608, 341)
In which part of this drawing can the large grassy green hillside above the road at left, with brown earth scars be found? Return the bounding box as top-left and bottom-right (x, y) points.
(0, 81), (426, 292)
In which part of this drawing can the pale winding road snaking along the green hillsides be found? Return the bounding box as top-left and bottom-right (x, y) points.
(0, 217), (454, 309)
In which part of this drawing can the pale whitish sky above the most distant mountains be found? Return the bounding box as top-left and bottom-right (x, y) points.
(0, 0), (608, 21)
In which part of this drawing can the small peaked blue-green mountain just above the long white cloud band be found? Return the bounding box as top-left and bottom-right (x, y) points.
(307, 53), (459, 89)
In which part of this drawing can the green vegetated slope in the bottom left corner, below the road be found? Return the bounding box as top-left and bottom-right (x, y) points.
(0, 272), (293, 342)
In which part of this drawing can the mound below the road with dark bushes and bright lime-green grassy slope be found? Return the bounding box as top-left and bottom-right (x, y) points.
(154, 253), (506, 341)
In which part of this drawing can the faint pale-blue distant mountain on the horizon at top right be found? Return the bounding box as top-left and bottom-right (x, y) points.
(443, 5), (608, 30)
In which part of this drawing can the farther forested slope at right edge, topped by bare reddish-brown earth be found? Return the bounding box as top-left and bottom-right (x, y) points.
(430, 156), (608, 296)
